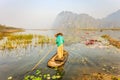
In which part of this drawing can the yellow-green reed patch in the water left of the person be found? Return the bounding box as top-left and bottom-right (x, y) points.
(0, 34), (55, 50)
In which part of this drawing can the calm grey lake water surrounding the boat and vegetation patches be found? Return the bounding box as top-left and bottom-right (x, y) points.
(0, 30), (120, 80)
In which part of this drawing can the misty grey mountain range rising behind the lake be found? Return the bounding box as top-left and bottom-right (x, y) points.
(53, 10), (120, 29)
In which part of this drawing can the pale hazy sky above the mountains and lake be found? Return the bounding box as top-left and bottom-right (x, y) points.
(0, 0), (120, 29)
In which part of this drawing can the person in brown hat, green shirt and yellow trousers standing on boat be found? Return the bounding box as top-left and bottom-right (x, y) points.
(55, 33), (64, 60)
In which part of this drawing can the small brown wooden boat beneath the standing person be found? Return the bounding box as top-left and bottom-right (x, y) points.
(48, 50), (68, 68)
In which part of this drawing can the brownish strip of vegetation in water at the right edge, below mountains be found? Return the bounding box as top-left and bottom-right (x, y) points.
(101, 35), (120, 48)
